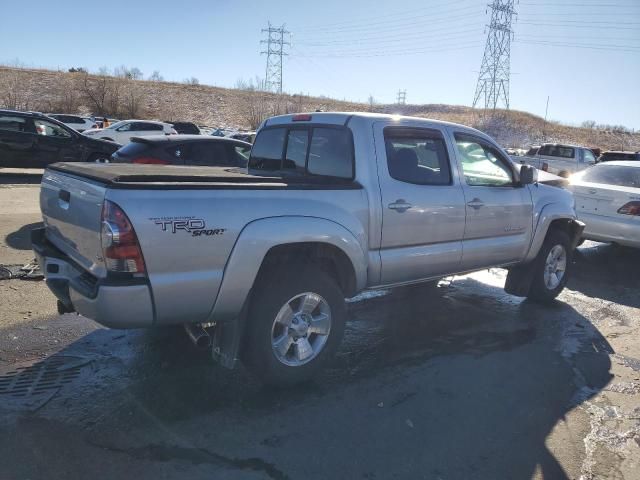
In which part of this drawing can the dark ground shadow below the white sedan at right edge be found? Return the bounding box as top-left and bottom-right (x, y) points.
(568, 242), (640, 308)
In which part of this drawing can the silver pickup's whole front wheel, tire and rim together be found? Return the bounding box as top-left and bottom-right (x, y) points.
(528, 230), (573, 303)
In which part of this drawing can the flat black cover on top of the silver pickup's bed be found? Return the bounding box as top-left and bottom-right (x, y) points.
(48, 162), (362, 190)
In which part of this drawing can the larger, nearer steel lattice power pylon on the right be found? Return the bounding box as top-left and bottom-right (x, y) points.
(473, 0), (516, 110)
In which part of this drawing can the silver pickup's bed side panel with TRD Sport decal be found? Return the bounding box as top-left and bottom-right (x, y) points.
(107, 189), (369, 324)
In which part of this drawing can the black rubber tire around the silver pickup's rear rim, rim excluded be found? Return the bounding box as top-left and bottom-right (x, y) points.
(243, 266), (347, 386)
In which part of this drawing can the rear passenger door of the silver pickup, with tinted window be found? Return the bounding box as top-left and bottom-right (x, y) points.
(374, 122), (465, 285)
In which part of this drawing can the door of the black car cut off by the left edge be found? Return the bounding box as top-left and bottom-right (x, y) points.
(0, 114), (36, 168)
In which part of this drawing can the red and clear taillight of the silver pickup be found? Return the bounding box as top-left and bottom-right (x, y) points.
(101, 200), (145, 273)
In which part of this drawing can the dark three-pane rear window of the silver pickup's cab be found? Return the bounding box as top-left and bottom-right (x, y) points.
(249, 125), (355, 180)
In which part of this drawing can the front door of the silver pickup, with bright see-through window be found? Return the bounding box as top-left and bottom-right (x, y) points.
(454, 132), (533, 270)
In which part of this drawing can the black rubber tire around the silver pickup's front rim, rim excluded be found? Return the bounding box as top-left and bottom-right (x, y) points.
(527, 230), (573, 303)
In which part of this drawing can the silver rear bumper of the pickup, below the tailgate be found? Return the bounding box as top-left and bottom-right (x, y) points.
(31, 228), (154, 328)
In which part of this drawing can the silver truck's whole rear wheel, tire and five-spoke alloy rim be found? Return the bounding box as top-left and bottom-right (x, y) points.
(244, 266), (346, 385)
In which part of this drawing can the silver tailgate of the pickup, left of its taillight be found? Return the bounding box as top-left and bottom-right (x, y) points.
(40, 170), (106, 278)
